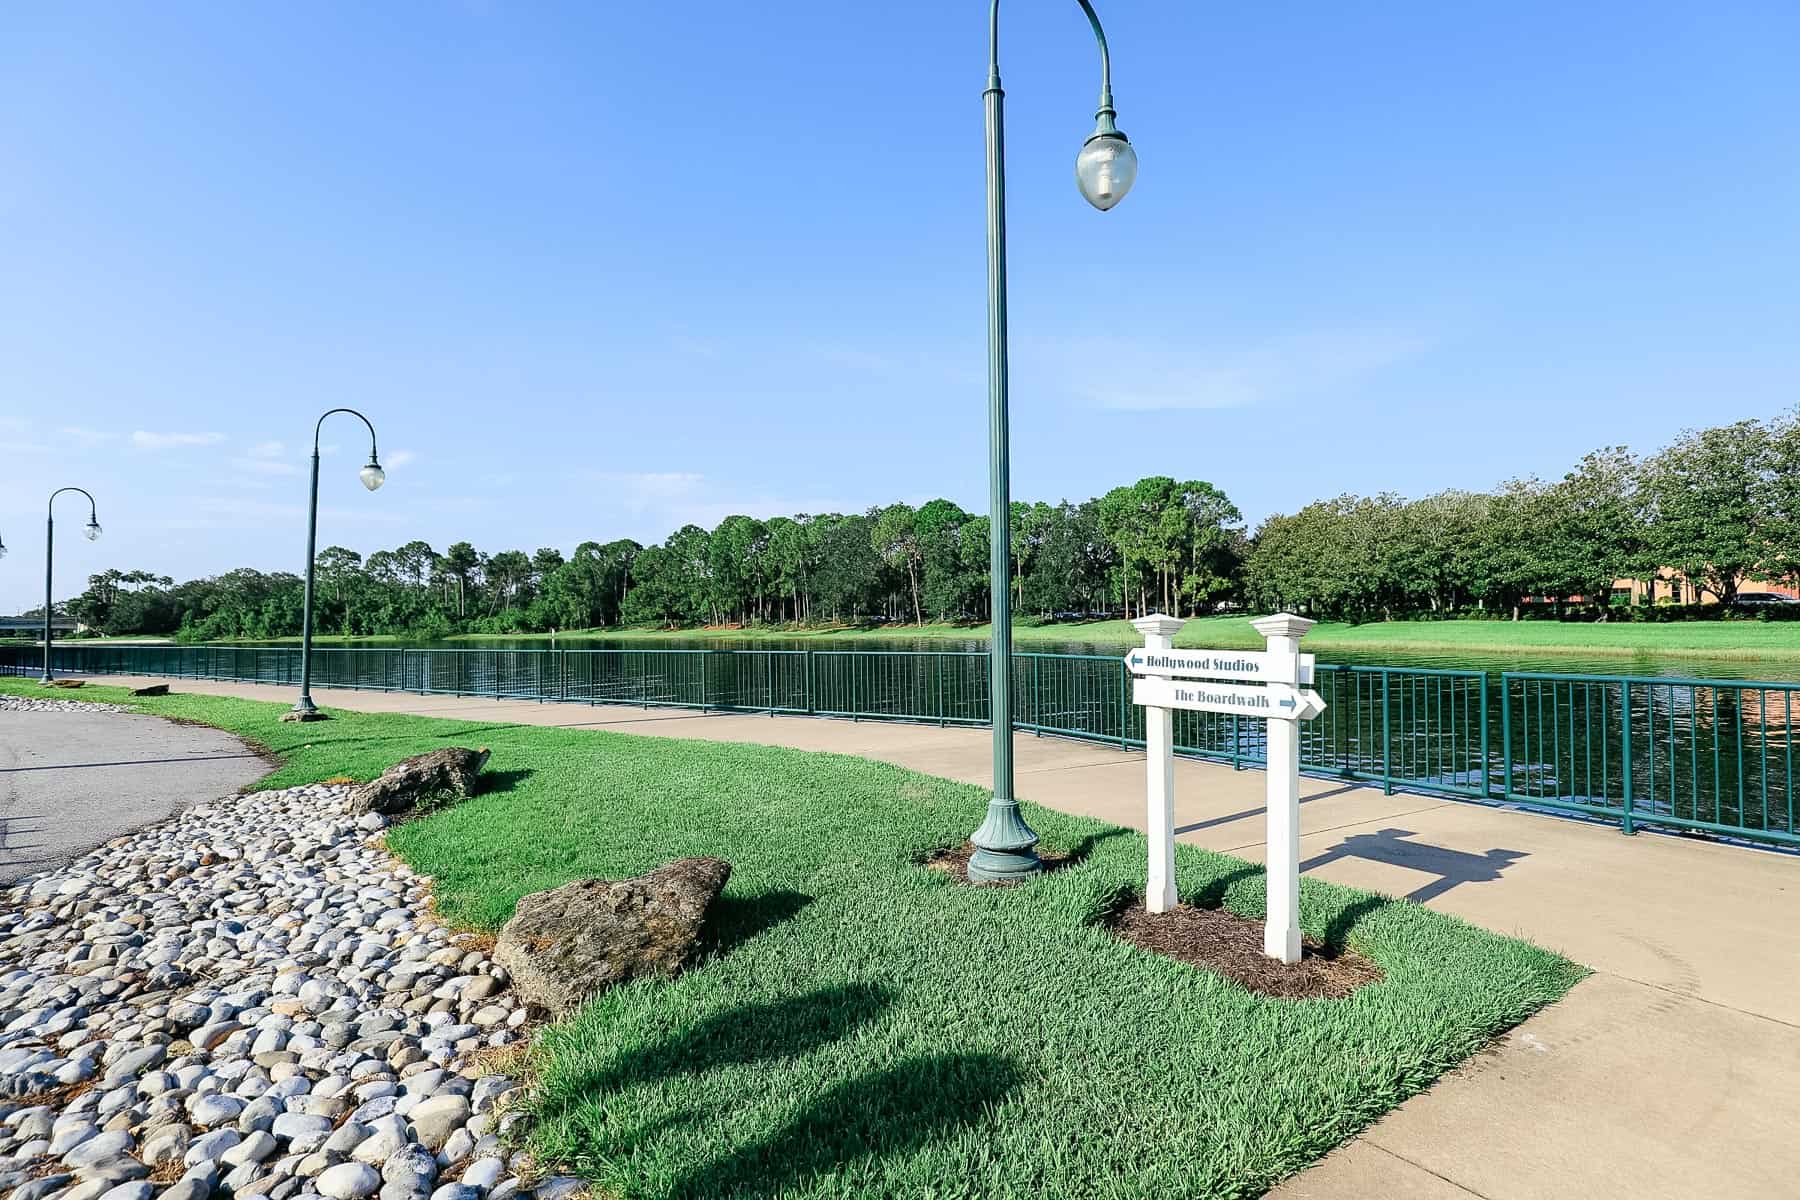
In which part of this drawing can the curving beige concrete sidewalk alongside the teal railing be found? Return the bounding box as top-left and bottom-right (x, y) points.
(77, 678), (1800, 1200)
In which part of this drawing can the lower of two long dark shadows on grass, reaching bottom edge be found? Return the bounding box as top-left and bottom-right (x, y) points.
(670, 1054), (1022, 1200)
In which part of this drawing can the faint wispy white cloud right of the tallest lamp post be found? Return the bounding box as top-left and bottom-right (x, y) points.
(1066, 329), (1427, 412)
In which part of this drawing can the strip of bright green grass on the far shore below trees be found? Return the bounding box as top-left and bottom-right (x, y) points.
(70, 615), (1800, 660)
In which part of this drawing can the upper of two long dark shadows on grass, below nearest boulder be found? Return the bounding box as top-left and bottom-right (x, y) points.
(565, 984), (895, 1105)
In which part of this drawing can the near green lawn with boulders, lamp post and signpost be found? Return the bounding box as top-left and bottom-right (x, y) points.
(0, 680), (1582, 1200)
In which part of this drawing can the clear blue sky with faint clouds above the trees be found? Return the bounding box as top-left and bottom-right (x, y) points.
(0, 0), (1800, 612)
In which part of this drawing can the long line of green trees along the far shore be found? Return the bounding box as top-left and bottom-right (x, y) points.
(42, 414), (1800, 640)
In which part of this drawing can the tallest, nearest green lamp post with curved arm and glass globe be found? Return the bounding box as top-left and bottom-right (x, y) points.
(968, 0), (1138, 882)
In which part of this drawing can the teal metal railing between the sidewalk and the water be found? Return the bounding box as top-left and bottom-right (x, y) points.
(0, 642), (1800, 846)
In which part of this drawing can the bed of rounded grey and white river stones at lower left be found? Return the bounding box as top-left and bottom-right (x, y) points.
(0, 780), (587, 1200)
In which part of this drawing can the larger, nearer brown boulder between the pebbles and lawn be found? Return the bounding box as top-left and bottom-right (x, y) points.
(493, 858), (731, 1015)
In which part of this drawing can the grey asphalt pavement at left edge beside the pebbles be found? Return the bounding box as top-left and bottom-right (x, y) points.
(0, 712), (270, 883)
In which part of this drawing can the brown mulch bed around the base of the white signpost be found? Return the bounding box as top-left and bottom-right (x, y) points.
(1107, 898), (1382, 1000)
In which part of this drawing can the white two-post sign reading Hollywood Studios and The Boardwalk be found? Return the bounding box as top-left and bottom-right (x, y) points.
(1125, 613), (1325, 963)
